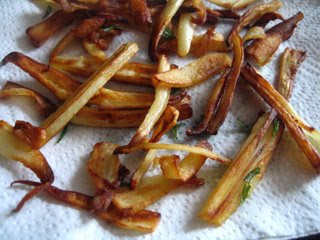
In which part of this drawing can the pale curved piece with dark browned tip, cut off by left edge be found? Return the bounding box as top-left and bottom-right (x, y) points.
(0, 121), (54, 183)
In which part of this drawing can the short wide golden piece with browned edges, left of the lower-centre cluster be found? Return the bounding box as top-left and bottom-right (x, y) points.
(87, 142), (120, 191)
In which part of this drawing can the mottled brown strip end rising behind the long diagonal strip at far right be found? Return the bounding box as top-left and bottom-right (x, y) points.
(278, 48), (306, 99)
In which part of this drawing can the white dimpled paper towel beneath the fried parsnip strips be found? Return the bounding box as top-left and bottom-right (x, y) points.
(0, 0), (320, 240)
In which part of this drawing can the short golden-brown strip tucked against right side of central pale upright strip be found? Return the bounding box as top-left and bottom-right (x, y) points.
(150, 106), (179, 142)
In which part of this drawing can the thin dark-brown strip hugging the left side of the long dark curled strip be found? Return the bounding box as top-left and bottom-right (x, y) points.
(186, 69), (229, 136)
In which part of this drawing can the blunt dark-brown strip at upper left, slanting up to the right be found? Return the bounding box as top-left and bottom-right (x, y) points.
(26, 10), (77, 47)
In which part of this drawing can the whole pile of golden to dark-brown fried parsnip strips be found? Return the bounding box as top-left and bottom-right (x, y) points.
(0, 0), (320, 232)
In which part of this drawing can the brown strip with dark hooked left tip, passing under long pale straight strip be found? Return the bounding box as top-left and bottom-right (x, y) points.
(3, 52), (154, 109)
